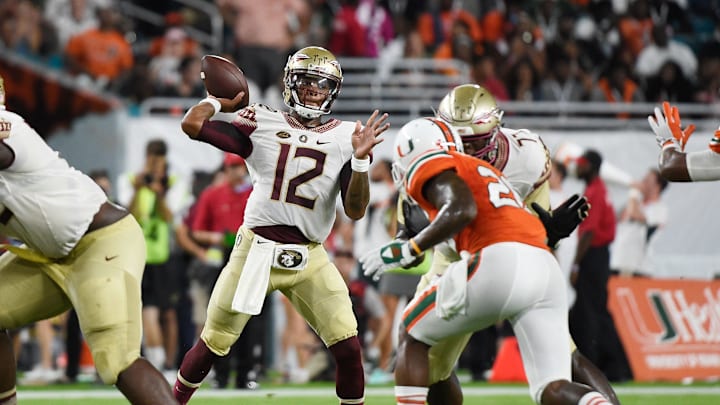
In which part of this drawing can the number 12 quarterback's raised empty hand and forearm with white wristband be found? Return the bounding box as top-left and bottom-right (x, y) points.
(343, 110), (390, 220)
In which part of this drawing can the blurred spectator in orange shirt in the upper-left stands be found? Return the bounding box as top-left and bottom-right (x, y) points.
(65, 7), (133, 87)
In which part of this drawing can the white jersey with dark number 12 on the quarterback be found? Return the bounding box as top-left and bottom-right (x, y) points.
(236, 104), (355, 242)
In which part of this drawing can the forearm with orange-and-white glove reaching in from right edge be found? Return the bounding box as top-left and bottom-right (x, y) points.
(648, 102), (720, 182)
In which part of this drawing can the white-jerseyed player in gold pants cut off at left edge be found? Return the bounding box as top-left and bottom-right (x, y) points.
(0, 79), (175, 405)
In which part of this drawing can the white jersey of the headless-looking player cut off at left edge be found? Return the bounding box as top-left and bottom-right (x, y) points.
(0, 110), (107, 258)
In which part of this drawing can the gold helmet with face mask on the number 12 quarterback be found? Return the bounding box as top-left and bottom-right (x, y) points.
(283, 46), (342, 119)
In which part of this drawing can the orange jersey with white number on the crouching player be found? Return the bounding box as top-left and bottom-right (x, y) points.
(406, 150), (547, 252)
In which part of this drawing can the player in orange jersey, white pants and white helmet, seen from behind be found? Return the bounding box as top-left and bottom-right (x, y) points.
(361, 118), (611, 405)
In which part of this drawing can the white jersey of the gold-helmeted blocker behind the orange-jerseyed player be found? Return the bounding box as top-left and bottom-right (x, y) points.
(493, 128), (552, 200)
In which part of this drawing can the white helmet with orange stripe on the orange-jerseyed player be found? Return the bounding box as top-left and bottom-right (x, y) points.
(392, 118), (463, 189)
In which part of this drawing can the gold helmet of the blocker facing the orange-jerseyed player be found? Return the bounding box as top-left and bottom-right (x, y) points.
(437, 84), (503, 164)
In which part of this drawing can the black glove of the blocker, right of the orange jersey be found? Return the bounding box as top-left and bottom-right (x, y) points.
(530, 194), (590, 249)
